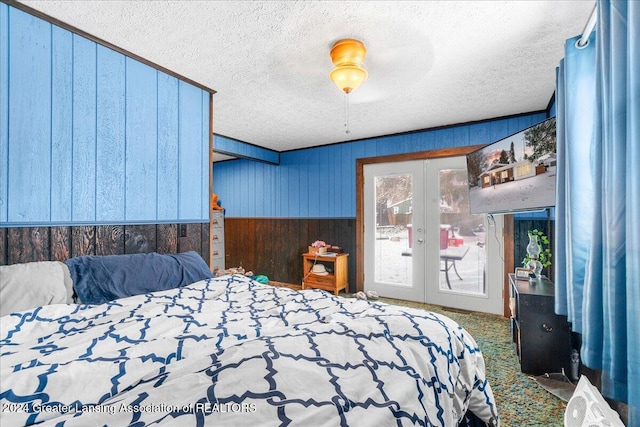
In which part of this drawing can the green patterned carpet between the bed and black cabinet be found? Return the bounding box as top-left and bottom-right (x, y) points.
(380, 298), (566, 427)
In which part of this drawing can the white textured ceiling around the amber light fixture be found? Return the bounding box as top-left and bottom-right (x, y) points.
(22, 0), (595, 151)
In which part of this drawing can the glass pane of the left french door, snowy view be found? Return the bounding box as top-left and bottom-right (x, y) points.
(375, 174), (413, 286)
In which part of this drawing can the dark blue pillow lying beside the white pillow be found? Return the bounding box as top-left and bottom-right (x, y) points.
(65, 251), (213, 304)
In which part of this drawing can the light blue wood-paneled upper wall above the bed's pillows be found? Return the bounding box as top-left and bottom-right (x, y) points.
(0, 3), (209, 226)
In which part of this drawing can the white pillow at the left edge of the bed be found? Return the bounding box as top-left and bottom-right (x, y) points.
(0, 261), (73, 316)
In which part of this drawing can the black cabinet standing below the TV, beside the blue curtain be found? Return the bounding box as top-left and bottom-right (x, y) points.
(509, 274), (571, 375)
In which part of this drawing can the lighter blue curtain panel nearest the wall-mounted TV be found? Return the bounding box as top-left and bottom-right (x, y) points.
(555, 35), (596, 332)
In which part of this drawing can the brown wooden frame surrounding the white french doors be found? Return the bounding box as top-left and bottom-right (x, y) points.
(356, 144), (514, 316)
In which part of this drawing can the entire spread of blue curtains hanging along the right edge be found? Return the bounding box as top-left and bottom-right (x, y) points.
(555, 1), (640, 425)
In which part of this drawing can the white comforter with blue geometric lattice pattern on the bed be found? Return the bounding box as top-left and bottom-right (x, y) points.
(0, 276), (498, 427)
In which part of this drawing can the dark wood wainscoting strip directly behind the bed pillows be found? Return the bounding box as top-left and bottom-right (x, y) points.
(0, 223), (209, 265)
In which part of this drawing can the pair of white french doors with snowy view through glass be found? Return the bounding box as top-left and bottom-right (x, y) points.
(363, 156), (503, 314)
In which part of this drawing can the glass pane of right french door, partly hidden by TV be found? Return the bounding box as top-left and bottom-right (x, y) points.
(440, 169), (486, 295)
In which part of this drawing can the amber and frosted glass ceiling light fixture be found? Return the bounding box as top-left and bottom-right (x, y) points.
(329, 39), (369, 93)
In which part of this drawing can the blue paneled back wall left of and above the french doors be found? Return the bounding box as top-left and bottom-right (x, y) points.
(213, 113), (547, 218)
